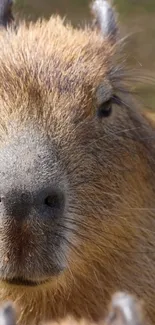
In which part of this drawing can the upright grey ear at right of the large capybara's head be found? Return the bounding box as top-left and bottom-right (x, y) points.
(91, 0), (118, 42)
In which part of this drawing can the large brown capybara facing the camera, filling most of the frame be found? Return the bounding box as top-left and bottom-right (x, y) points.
(0, 0), (155, 325)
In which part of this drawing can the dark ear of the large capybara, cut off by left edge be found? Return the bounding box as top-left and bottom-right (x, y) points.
(0, 0), (14, 28)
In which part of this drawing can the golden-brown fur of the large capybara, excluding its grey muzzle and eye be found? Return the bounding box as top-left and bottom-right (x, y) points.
(0, 5), (155, 325)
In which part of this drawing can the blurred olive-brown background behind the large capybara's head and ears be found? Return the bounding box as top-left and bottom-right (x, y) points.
(15, 0), (155, 111)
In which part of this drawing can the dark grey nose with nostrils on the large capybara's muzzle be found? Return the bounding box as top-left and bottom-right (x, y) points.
(0, 189), (64, 221)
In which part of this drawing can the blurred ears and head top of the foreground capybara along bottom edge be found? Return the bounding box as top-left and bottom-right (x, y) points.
(0, 292), (145, 325)
